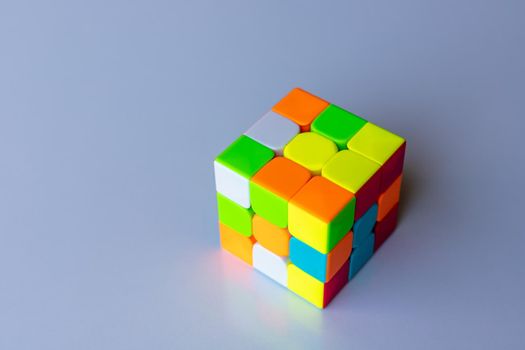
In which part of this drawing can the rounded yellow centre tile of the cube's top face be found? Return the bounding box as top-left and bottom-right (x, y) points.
(284, 132), (337, 175)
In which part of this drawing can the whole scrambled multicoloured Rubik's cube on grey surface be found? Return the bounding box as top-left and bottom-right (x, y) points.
(214, 88), (406, 308)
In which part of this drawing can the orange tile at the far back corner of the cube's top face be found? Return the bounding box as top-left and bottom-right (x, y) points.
(272, 88), (328, 131)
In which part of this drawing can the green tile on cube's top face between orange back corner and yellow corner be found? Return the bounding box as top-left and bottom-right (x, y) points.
(312, 105), (367, 150)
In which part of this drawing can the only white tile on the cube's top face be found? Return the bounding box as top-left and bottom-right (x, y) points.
(244, 112), (300, 155)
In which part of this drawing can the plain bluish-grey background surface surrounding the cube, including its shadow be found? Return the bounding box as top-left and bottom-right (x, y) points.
(0, 0), (525, 350)
